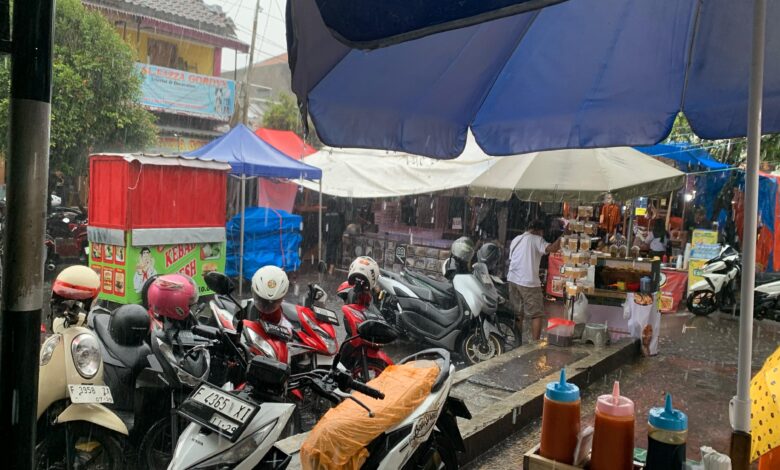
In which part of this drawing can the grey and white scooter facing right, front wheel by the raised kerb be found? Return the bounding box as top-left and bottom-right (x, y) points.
(378, 263), (506, 364)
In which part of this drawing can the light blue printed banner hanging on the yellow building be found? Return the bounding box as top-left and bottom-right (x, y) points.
(135, 63), (236, 122)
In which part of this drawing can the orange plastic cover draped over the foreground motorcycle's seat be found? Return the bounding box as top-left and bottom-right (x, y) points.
(300, 361), (439, 470)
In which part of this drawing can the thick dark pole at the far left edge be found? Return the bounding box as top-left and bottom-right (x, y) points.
(0, 0), (54, 469)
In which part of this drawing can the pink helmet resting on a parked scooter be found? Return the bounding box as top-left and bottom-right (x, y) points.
(147, 274), (198, 320)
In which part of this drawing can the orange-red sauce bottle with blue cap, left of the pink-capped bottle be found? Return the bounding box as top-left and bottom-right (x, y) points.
(539, 369), (580, 465)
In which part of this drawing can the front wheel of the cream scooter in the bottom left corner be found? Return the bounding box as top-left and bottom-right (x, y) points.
(35, 422), (125, 470)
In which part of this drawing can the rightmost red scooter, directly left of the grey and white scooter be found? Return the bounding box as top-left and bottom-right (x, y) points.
(338, 277), (393, 382)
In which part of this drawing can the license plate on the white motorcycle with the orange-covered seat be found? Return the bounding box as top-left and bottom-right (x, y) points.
(179, 384), (259, 442)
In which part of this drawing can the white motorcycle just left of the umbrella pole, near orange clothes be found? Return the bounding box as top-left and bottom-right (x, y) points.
(686, 245), (742, 316)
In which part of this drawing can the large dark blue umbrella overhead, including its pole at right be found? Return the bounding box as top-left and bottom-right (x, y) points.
(287, 0), (780, 462)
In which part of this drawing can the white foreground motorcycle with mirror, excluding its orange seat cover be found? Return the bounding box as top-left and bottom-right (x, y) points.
(169, 320), (471, 470)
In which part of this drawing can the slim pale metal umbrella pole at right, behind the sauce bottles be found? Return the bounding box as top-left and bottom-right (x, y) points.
(730, 0), (766, 470)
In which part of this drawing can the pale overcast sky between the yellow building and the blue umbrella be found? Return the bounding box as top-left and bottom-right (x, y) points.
(212, 0), (287, 75)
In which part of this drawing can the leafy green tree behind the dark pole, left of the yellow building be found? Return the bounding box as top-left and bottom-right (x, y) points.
(0, 0), (157, 176)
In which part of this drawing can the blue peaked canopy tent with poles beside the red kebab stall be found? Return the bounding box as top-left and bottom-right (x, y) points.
(185, 124), (322, 294)
